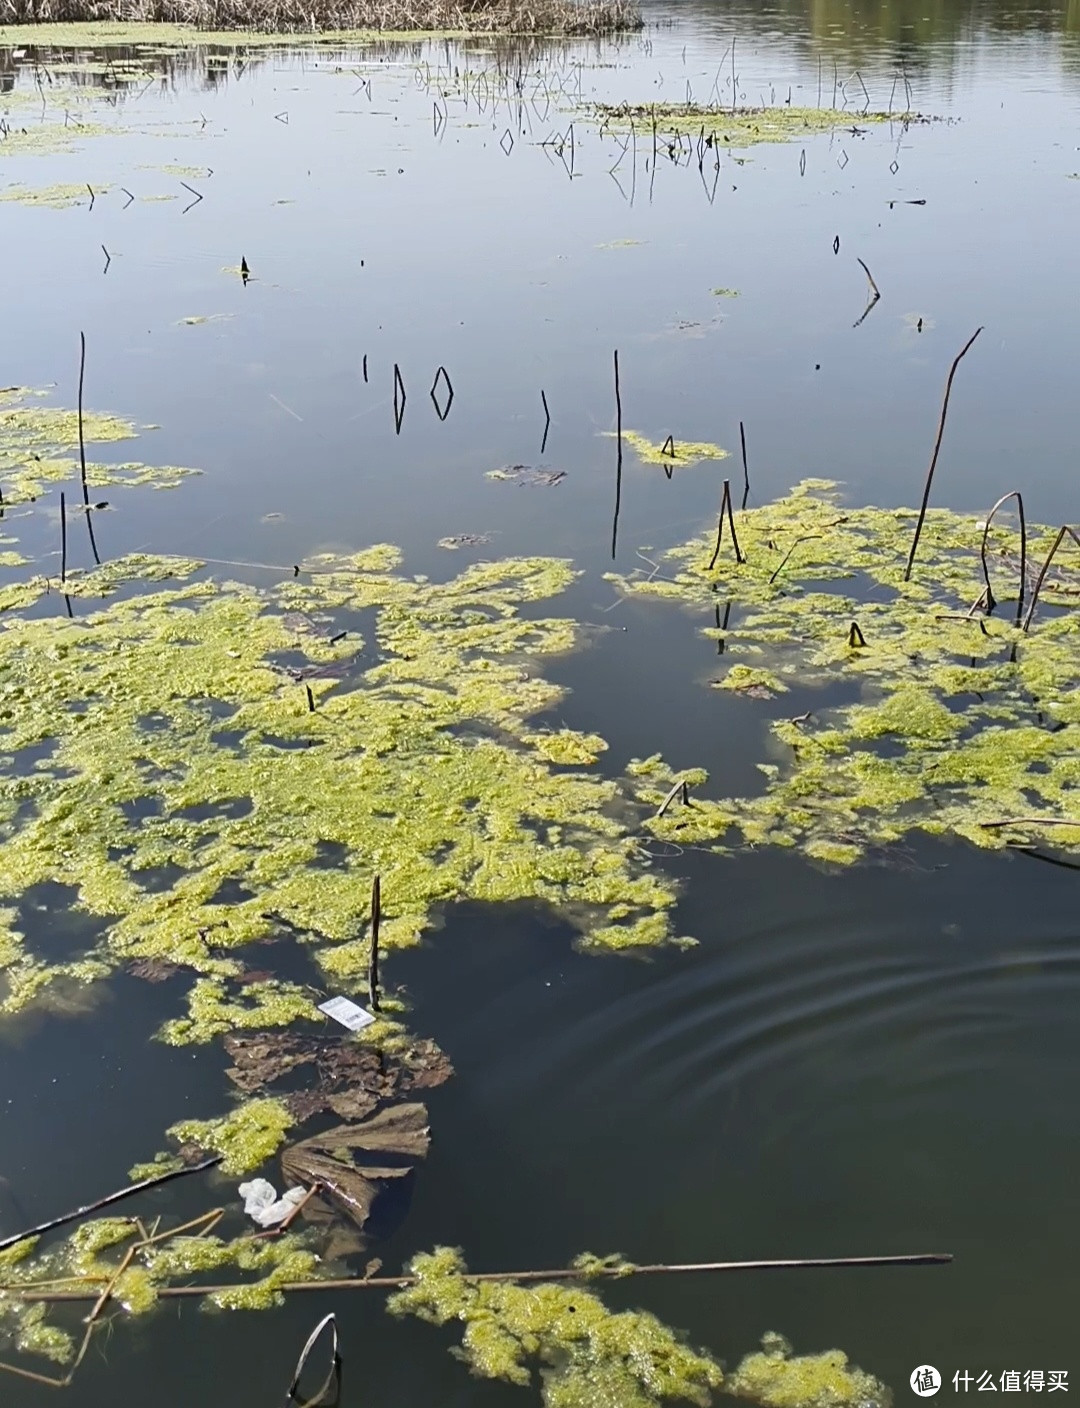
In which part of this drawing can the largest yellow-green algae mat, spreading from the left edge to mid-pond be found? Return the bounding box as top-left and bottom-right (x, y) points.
(0, 546), (674, 1019)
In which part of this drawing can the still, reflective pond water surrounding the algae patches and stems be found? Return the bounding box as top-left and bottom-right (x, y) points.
(0, 0), (1080, 1408)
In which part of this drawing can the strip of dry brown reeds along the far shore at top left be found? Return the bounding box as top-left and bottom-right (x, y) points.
(0, 0), (643, 35)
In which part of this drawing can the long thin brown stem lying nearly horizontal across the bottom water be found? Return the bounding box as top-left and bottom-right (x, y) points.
(8, 1252), (953, 1302)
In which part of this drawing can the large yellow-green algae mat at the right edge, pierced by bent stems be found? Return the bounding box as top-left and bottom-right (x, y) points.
(610, 482), (1080, 865)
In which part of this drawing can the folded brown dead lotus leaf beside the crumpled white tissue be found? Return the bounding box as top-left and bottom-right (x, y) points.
(282, 1104), (431, 1228)
